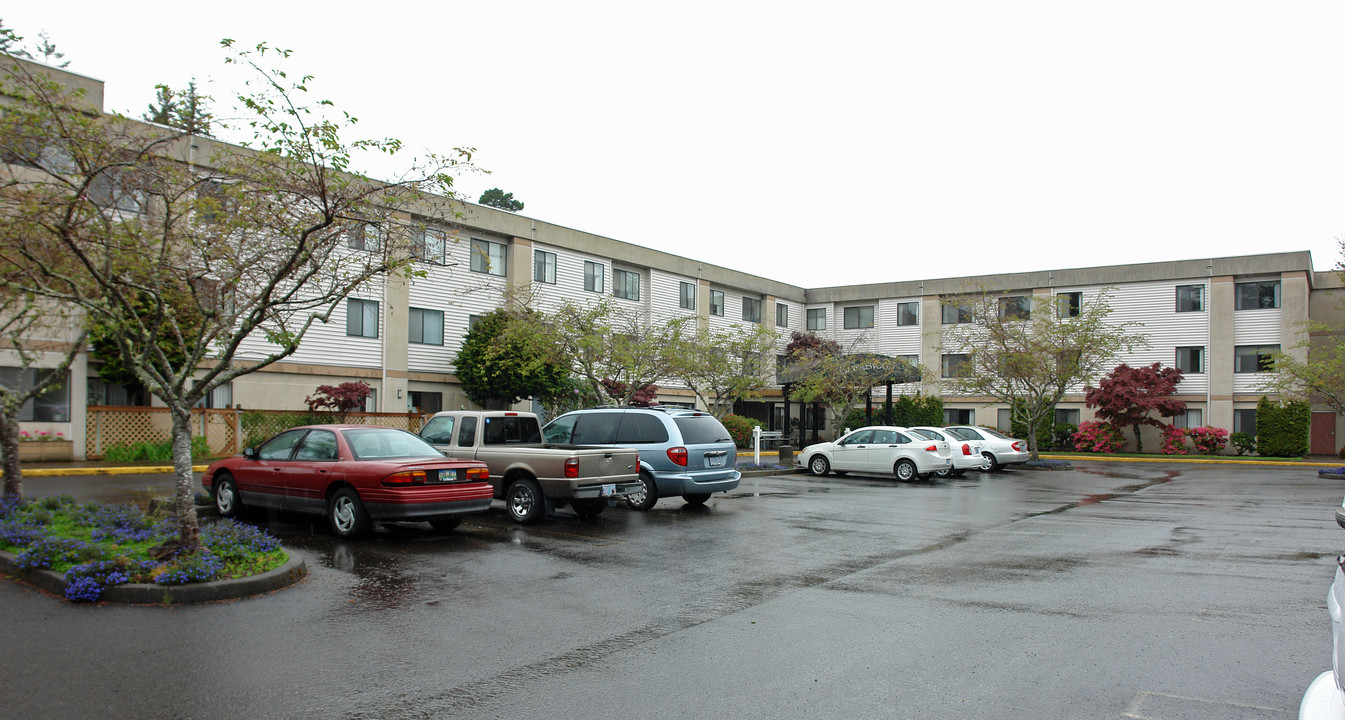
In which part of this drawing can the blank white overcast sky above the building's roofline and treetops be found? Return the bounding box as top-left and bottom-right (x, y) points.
(0, 0), (1345, 287)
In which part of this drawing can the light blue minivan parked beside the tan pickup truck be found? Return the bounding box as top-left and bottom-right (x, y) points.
(542, 408), (742, 510)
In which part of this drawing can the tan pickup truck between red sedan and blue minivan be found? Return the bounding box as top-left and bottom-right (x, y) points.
(420, 410), (640, 524)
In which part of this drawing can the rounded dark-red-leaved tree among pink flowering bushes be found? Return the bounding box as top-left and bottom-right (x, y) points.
(1084, 362), (1186, 452)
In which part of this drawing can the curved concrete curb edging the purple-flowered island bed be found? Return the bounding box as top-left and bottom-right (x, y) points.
(0, 549), (308, 604)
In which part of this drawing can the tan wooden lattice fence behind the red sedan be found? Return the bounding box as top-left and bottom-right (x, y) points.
(85, 405), (425, 459)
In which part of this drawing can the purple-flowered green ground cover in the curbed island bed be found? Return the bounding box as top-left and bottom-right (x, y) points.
(0, 495), (289, 602)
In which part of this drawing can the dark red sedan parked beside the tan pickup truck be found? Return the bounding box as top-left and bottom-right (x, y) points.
(200, 425), (495, 537)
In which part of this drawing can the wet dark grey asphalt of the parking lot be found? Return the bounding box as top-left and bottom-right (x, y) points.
(0, 463), (1345, 720)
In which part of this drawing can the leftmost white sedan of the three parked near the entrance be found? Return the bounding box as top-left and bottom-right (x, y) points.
(794, 425), (952, 480)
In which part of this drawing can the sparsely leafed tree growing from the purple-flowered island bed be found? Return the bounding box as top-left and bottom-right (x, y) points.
(0, 46), (469, 548)
